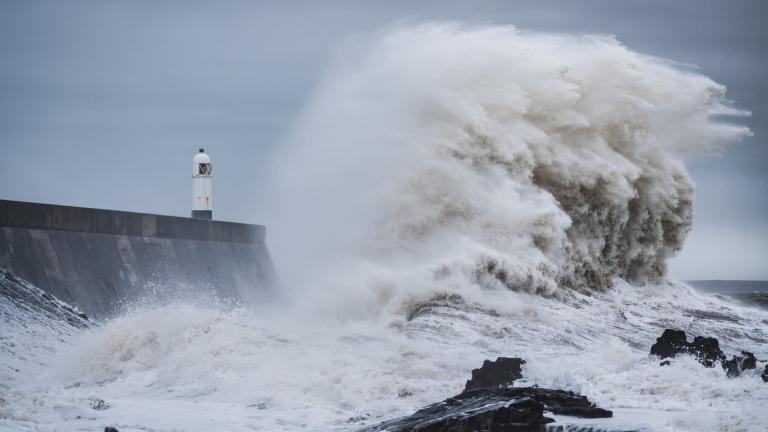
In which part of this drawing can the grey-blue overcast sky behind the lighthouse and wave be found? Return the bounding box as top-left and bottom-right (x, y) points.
(0, 0), (768, 279)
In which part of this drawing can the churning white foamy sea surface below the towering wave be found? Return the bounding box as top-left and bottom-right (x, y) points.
(0, 281), (768, 431)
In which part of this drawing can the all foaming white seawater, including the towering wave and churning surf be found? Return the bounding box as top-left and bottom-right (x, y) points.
(0, 24), (768, 431)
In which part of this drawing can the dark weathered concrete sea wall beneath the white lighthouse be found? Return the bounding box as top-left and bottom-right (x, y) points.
(0, 200), (275, 317)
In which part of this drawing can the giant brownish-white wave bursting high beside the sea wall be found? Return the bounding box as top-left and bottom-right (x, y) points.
(278, 24), (750, 308)
